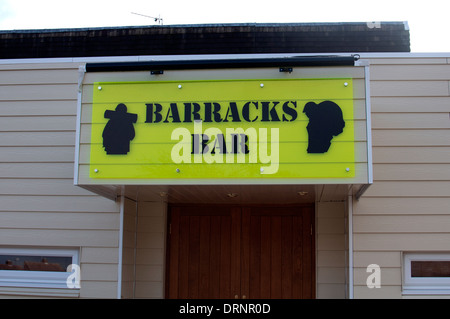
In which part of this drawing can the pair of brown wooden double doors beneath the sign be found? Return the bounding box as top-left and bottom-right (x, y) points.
(166, 206), (315, 299)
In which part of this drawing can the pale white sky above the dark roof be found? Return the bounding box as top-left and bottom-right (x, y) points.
(0, 0), (450, 53)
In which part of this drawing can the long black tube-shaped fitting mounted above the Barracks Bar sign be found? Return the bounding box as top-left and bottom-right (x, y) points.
(86, 55), (359, 72)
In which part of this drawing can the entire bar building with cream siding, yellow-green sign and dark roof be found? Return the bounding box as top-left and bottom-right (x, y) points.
(0, 24), (450, 299)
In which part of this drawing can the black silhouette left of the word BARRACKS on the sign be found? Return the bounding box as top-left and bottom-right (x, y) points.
(102, 103), (137, 155)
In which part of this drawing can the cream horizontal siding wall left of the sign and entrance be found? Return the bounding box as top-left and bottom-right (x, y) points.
(0, 63), (120, 298)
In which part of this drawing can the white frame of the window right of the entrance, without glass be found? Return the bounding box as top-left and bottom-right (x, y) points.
(403, 252), (450, 295)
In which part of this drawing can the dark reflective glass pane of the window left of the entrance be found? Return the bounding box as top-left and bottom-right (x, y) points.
(0, 255), (72, 271)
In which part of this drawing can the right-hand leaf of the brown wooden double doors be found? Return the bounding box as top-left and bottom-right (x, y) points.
(241, 207), (314, 299)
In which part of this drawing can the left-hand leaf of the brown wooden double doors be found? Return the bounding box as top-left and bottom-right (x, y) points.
(167, 207), (240, 299)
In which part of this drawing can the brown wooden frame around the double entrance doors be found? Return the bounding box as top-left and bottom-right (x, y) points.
(164, 203), (317, 299)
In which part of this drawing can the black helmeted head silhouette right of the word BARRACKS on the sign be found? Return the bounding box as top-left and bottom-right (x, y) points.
(303, 101), (345, 153)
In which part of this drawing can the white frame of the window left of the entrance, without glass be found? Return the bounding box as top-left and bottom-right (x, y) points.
(0, 248), (79, 288)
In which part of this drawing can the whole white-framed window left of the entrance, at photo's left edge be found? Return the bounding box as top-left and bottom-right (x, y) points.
(0, 248), (79, 288)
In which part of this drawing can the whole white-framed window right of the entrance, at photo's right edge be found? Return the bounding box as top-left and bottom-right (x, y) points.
(403, 253), (450, 294)
